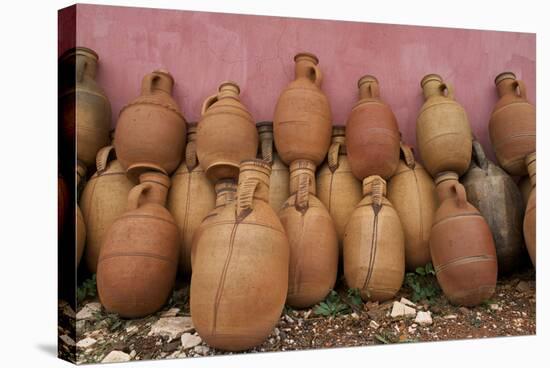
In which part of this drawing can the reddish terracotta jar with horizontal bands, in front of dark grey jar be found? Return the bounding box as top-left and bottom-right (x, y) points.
(430, 172), (497, 307)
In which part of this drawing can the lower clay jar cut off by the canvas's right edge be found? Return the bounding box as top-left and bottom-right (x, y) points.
(523, 152), (537, 268)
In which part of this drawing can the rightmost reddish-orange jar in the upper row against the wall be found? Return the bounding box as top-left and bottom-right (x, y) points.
(489, 72), (536, 175)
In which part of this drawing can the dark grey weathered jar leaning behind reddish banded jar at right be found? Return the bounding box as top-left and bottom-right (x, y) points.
(461, 140), (524, 274)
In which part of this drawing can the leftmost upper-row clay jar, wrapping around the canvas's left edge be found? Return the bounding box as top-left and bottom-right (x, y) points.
(59, 47), (111, 167)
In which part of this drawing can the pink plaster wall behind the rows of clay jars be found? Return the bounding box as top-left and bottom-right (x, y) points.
(66, 5), (535, 157)
